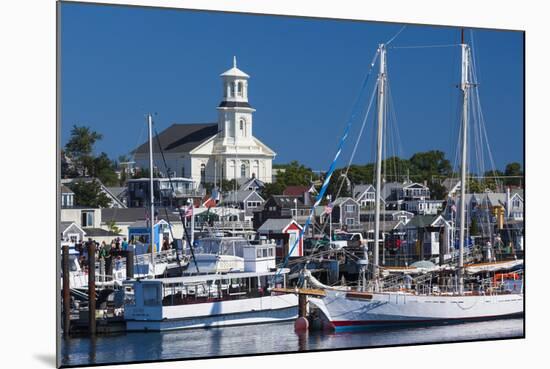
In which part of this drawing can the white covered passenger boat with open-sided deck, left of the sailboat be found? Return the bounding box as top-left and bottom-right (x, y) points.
(123, 242), (298, 331)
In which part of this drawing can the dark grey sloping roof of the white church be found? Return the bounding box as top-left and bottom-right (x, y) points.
(134, 123), (218, 154)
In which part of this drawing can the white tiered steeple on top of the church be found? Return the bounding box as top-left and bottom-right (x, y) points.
(218, 56), (255, 145)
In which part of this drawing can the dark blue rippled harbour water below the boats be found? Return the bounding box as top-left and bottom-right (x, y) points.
(61, 318), (524, 366)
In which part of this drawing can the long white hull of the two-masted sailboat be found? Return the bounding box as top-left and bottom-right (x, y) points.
(310, 290), (523, 331)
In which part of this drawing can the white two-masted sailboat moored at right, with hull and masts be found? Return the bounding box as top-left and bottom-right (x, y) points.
(306, 41), (524, 331)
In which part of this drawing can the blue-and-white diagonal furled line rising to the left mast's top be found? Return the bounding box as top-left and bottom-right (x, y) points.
(272, 49), (380, 283)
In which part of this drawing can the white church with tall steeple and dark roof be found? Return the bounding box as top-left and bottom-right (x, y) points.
(134, 58), (276, 187)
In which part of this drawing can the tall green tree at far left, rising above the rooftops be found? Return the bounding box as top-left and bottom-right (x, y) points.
(65, 125), (103, 176)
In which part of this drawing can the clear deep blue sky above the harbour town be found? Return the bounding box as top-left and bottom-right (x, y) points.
(61, 3), (523, 170)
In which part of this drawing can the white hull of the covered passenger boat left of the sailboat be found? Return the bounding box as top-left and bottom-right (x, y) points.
(125, 295), (298, 331)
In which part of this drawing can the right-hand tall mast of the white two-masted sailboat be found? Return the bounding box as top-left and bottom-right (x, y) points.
(458, 40), (470, 293)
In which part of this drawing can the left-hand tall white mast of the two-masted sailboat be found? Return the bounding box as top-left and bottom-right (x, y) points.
(373, 44), (386, 288)
